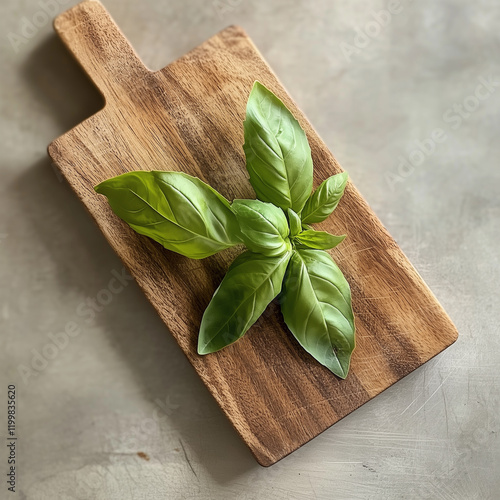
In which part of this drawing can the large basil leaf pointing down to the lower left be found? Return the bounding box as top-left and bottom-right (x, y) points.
(198, 251), (291, 354)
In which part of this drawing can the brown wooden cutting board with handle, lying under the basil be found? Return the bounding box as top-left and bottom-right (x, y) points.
(48, 1), (457, 466)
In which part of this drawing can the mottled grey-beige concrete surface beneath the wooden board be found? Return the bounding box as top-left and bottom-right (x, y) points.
(0, 0), (500, 500)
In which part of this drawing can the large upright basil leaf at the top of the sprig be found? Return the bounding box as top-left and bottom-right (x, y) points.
(243, 82), (313, 213)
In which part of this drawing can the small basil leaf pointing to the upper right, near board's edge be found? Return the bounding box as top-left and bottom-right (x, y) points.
(301, 172), (348, 224)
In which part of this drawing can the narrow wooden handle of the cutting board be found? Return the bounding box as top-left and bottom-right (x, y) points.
(54, 0), (150, 101)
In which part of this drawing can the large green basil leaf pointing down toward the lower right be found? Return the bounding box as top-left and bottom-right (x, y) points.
(281, 250), (355, 378)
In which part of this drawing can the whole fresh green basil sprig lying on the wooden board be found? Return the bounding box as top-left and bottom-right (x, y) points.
(95, 82), (355, 378)
